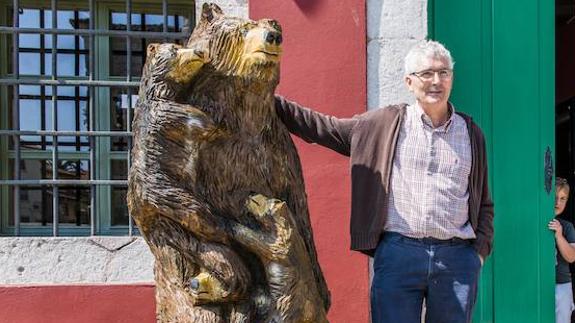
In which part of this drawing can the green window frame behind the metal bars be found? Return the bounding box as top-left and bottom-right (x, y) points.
(0, 0), (195, 236)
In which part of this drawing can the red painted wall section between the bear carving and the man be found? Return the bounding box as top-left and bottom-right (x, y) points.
(250, 0), (369, 323)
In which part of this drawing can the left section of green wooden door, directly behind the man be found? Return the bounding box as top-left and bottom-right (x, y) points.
(429, 0), (494, 322)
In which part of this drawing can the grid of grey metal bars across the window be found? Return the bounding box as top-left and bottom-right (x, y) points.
(0, 0), (192, 236)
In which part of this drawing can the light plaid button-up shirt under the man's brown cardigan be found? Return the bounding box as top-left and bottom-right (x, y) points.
(385, 104), (475, 239)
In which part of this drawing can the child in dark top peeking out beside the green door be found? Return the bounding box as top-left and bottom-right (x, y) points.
(549, 177), (575, 323)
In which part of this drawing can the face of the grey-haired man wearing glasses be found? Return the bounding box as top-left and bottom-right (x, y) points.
(405, 58), (453, 107)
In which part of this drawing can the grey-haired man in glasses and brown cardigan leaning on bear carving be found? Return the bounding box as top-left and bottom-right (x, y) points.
(276, 41), (493, 323)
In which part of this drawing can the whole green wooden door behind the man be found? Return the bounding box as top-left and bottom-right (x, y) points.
(428, 0), (555, 323)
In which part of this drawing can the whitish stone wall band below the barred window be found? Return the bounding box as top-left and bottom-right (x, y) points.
(0, 237), (154, 285)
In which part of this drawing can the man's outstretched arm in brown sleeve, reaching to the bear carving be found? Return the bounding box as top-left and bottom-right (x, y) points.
(275, 95), (358, 156)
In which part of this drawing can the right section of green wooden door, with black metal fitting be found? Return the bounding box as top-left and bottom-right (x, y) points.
(493, 0), (555, 322)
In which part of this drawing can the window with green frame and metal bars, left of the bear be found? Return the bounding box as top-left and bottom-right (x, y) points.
(0, 0), (194, 236)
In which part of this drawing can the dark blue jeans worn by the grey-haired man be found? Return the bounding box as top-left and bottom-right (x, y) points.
(371, 232), (481, 323)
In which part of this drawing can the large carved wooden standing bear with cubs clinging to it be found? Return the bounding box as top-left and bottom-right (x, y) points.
(128, 4), (329, 323)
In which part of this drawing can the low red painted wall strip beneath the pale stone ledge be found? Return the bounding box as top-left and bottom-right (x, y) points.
(0, 285), (156, 323)
